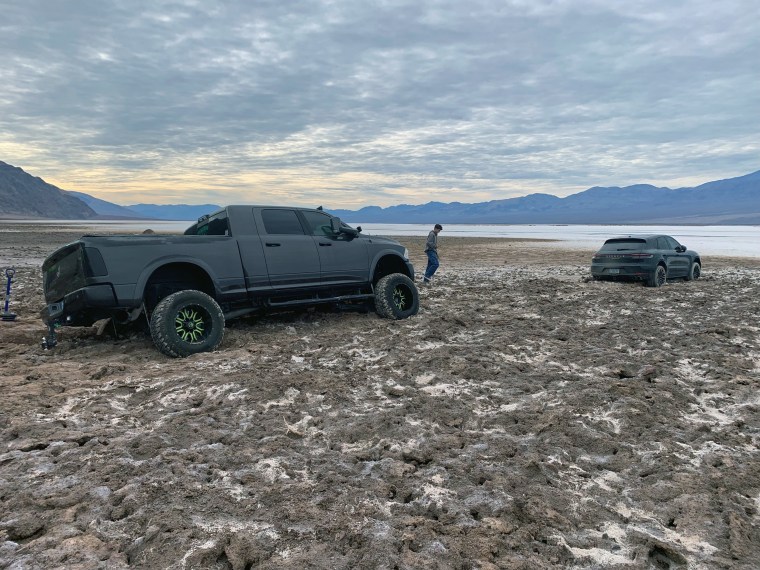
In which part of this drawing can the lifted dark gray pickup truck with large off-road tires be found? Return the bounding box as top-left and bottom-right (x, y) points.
(42, 206), (419, 357)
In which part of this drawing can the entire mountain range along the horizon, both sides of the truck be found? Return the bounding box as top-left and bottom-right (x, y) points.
(0, 161), (760, 225)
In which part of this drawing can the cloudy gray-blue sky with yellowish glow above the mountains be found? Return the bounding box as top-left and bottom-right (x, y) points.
(0, 0), (760, 208)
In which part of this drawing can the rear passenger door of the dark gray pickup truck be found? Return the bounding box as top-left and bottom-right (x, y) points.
(259, 208), (320, 289)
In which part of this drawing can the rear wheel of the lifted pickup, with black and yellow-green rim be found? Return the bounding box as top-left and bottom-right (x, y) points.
(150, 290), (224, 358)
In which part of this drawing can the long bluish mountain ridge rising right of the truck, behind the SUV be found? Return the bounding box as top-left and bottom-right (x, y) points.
(330, 171), (760, 225)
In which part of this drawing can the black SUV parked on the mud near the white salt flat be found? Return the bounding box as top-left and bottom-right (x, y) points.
(591, 235), (702, 287)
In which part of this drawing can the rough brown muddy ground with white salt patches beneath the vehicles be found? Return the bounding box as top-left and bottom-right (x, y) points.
(0, 225), (760, 570)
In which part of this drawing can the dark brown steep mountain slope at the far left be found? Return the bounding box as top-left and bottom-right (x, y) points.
(0, 161), (97, 220)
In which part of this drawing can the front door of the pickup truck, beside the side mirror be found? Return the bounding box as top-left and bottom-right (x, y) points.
(300, 210), (369, 285)
